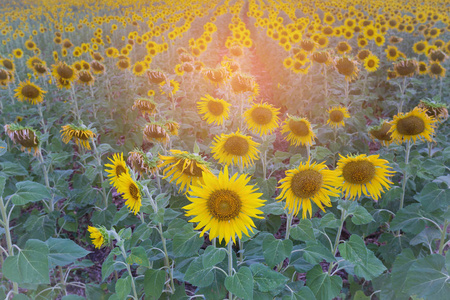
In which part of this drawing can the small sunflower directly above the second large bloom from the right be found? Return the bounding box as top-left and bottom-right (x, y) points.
(281, 115), (316, 146)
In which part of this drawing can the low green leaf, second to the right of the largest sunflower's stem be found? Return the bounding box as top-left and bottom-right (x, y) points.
(250, 263), (288, 292)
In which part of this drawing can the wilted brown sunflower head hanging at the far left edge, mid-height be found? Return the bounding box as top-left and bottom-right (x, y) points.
(4, 124), (40, 155)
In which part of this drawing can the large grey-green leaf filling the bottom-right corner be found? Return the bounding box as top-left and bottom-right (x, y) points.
(405, 254), (450, 300)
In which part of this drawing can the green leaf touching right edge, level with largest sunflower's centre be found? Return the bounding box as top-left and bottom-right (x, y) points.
(414, 182), (450, 212)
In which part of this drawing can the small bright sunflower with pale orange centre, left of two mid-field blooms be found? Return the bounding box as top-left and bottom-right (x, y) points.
(197, 94), (231, 125)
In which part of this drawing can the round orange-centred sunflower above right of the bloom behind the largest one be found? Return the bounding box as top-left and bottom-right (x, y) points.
(244, 103), (280, 135)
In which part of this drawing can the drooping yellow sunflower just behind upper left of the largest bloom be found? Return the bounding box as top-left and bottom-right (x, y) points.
(158, 149), (212, 191)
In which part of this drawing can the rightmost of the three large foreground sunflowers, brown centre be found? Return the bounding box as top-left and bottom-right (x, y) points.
(336, 154), (395, 201)
